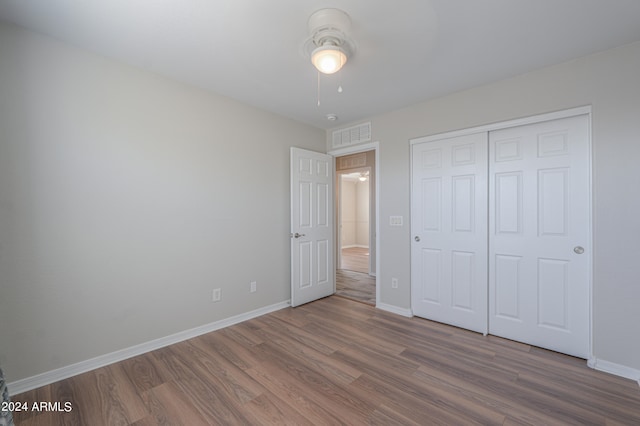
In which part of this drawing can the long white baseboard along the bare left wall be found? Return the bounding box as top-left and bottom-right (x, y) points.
(7, 300), (291, 395)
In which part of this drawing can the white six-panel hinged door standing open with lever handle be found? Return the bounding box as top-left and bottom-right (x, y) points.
(291, 148), (335, 306)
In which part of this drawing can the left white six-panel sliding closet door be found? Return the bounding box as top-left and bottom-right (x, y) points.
(411, 132), (487, 333)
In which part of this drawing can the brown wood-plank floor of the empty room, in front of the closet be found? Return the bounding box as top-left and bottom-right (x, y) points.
(13, 297), (640, 426)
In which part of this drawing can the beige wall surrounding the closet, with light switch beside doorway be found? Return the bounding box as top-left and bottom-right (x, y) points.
(327, 42), (640, 370)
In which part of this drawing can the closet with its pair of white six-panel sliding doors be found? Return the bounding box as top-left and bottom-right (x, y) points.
(411, 108), (591, 358)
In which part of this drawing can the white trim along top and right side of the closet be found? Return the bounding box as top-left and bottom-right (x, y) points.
(410, 105), (595, 360)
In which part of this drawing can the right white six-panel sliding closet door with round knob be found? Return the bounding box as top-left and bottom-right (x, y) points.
(489, 115), (591, 358)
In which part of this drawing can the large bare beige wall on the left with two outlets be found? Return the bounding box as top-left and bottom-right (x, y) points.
(0, 25), (325, 382)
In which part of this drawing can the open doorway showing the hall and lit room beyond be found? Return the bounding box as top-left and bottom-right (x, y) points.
(336, 150), (376, 305)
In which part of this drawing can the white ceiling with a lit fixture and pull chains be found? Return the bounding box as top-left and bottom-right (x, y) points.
(0, 0), (640, 128)
